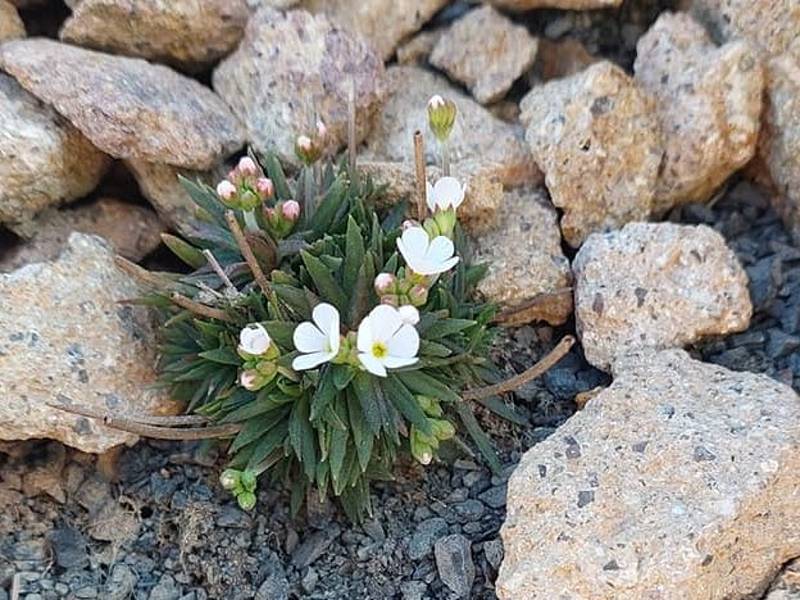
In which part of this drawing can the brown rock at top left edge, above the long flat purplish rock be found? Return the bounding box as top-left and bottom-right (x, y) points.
(59, 0), (250, 71)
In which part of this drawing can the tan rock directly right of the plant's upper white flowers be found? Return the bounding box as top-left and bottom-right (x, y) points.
(474, 190), (572, 325)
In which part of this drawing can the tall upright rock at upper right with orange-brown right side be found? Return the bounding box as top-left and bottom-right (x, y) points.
(634, 12), (764, 214)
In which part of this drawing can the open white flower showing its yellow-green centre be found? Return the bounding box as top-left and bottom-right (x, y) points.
(357, 304), (419, 377)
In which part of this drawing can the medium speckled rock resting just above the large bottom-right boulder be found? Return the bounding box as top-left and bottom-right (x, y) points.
(572, 223), (753, 370)
